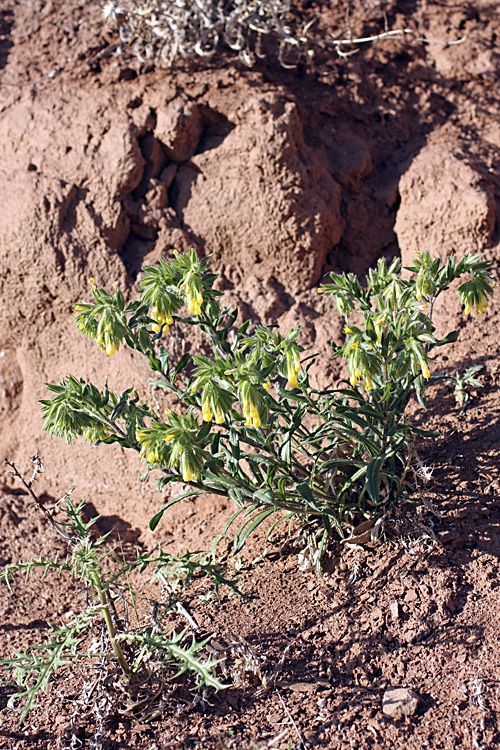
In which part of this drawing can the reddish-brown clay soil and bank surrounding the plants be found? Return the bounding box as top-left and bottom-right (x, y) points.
(0, 0), (500, 750)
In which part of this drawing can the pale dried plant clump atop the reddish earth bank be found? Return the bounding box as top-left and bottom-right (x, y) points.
(103, 0), (465, 68)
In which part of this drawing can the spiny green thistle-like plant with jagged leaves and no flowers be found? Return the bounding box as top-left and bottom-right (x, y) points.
(0, 498), (232, 721)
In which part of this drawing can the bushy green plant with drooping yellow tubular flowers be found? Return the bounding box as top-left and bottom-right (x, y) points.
(42, 250), (494, 560)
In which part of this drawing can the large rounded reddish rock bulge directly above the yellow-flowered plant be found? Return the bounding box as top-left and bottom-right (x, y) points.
(174, 91), (344, 293)
